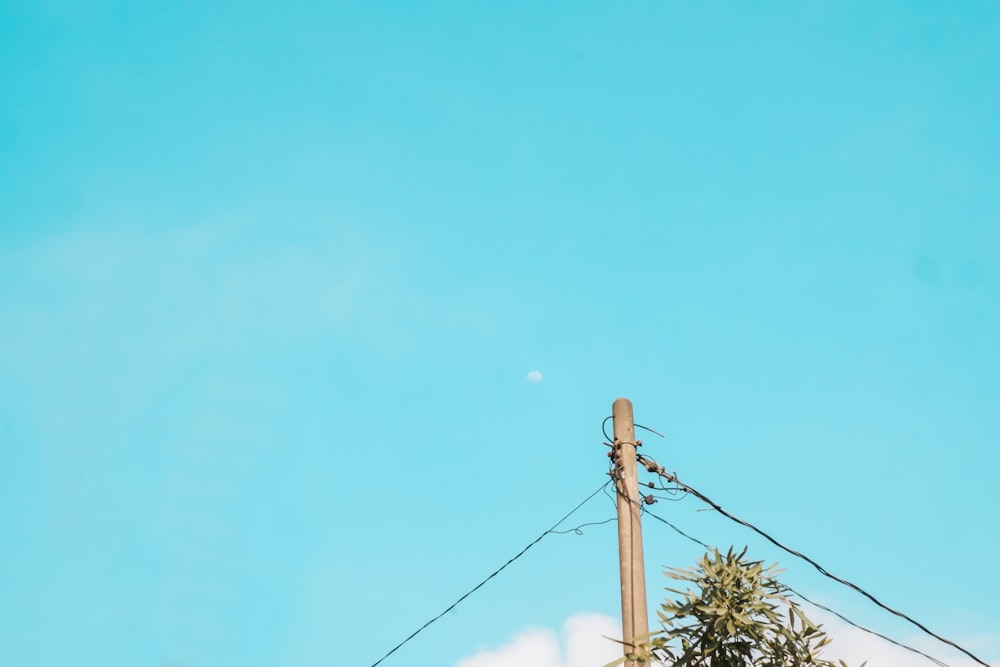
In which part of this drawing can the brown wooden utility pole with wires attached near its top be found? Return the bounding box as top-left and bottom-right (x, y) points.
(611, 398), (649, 667)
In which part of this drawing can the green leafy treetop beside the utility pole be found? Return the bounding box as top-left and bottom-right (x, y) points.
(605, 549), (864, 667)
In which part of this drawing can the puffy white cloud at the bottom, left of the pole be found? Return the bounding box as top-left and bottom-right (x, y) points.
(455, 614), (621, 667)
